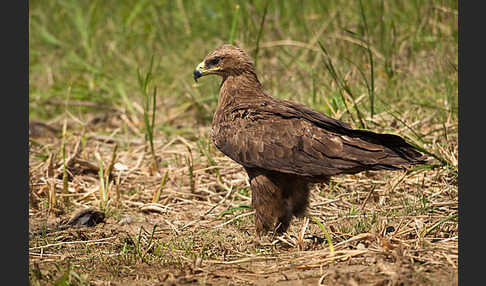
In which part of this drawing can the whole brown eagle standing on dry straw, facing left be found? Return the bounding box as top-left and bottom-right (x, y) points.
(194, 45), (425, 233)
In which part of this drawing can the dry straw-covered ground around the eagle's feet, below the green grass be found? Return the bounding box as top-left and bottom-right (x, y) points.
(29, 108), (458, 285)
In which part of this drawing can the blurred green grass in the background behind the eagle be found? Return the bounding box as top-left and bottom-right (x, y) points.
(29, 0), (458, 144)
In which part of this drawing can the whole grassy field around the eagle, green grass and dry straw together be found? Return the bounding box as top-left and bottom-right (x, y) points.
(29, 0), (459, 285)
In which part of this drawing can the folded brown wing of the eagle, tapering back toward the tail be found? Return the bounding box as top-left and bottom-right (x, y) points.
(213, 98), (421, 177)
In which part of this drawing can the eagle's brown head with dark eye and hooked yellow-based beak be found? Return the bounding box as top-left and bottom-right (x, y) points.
(194, 45), (254, 81)
